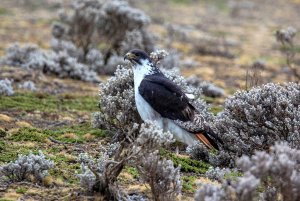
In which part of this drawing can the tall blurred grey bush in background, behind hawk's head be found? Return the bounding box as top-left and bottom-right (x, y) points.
(52, 0), (153, 74)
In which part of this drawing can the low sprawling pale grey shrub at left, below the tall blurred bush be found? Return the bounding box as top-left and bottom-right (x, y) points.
(2, 44), (99, 82)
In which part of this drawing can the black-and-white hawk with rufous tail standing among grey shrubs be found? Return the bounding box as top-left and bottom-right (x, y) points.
(124, 49), (223, 150)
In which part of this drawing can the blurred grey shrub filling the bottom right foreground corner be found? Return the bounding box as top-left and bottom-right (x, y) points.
(195, 143), (300, 201)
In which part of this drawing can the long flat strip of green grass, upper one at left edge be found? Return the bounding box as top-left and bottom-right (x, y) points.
(0, 93), (98, 113)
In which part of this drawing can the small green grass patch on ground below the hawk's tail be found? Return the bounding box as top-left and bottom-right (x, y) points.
(160, 150), (210, 174)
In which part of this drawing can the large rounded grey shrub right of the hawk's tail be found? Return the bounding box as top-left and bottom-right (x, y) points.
(189, 83), (300, 166)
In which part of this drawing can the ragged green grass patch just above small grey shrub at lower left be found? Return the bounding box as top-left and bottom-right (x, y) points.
(0, 123), (106, 163)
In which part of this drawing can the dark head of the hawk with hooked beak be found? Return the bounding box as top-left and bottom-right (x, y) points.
(124, 49), (152, 65)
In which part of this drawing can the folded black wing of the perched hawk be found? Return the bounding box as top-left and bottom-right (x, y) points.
(139, 75), (195, 121)
